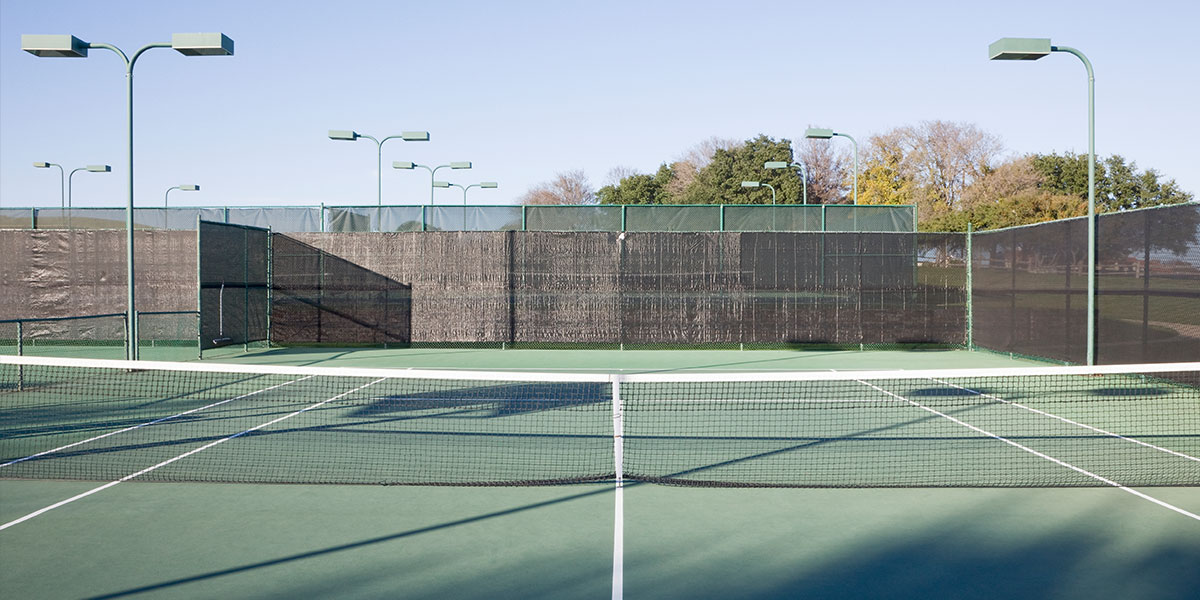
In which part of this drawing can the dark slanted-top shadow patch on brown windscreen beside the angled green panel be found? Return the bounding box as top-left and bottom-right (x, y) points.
(271, 234), (412, 344)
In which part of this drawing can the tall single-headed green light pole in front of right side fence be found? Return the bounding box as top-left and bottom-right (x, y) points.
(988, 37), (1096, 365)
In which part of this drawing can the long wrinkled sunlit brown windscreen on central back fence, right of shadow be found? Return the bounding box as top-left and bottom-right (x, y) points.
(280, 232), (966, 347)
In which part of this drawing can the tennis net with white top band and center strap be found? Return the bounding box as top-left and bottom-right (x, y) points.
(0, 356), (1200, 487)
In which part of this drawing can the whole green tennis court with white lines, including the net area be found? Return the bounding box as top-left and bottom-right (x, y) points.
(7, 348), (1200, 598)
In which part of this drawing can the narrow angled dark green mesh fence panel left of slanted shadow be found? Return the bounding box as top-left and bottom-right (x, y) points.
(199, 221), (270, 349)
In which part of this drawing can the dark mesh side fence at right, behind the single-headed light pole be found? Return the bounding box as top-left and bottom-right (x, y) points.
(972, 204), (1200, 365)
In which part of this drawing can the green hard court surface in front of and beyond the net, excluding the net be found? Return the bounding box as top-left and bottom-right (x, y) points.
(0, 348), (1200, 599)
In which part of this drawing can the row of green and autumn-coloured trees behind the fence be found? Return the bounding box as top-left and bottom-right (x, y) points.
(522, 121), (1194, 232)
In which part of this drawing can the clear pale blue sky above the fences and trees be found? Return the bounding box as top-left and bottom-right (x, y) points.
(0, 0), (1200, 206)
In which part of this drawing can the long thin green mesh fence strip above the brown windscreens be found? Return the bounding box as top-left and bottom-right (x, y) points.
(0, 204), (917, 233)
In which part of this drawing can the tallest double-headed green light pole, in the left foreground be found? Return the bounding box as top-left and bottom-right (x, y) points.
(20, 34), (233, 360)
